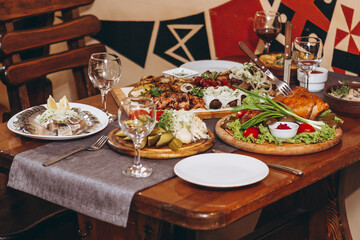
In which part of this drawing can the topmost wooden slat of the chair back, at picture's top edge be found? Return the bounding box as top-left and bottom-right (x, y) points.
(0, 0), (94, 21)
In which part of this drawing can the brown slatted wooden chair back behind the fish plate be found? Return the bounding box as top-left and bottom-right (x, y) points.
(0, 0), (105, 121)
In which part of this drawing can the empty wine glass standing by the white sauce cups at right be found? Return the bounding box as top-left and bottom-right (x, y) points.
(293, 36), (323, 89)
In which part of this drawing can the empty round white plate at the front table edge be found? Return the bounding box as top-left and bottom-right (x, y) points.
(174, 153), (269, 188)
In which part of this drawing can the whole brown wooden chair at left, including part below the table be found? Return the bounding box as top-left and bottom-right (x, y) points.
(0, 0), (106, 239)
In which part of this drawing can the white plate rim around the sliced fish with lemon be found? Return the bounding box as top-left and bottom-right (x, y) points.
(7, 103), (108, 140)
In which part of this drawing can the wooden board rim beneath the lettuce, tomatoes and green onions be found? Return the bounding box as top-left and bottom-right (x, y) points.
(215, 115), (343, 155)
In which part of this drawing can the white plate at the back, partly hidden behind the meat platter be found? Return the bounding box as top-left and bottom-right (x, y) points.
(180, 60), (242, 74)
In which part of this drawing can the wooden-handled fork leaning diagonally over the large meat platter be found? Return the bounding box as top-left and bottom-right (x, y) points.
(239, 41), (293, 96)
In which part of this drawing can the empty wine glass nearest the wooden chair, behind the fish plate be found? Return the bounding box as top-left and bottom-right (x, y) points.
(88, 52), (121, 122)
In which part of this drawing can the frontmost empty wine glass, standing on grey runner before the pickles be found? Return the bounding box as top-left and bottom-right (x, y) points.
(118, 97), (156, 178)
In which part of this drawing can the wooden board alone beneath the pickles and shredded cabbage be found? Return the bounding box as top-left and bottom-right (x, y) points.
(108, 128), (215, 159)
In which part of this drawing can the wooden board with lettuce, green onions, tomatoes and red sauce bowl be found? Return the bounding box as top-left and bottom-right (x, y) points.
(215, 86), (343, 155)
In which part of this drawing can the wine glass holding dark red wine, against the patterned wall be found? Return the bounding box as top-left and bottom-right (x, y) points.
(254, 11), (281, 53)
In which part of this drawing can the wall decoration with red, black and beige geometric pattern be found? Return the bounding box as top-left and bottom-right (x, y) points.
(83, 0), (360, 85)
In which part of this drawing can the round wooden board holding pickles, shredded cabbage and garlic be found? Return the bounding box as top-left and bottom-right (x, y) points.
(108, 110), (215, 159)
